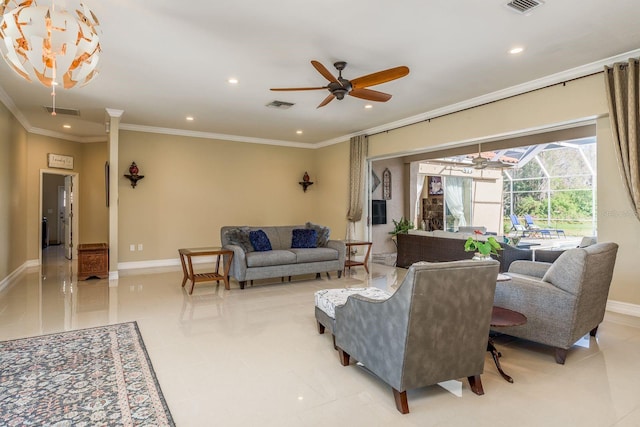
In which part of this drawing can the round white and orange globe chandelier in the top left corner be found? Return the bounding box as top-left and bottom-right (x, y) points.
(0, 0), (100, 116)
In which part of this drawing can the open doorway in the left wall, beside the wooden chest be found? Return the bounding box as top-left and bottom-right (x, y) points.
(40, 170), (78, 264)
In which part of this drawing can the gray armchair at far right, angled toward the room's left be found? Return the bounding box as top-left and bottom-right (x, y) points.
(494, 243), (618, 364)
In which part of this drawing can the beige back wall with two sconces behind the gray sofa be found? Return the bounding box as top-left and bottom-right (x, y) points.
(112, 131), (324, 262)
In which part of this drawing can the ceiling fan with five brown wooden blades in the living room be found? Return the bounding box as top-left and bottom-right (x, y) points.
(271, 61), (409, 108)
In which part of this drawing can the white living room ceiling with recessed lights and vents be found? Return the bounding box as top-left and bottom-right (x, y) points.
(0, 0), (640, 146)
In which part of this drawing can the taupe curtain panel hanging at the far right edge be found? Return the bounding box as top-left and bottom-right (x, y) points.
(604, 58), (640, 220)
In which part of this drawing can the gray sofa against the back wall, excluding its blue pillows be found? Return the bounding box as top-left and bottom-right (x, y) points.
(220, 223), (346, 289)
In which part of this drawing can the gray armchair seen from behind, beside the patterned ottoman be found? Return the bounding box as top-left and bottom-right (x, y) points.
(335, 260), (499, 414)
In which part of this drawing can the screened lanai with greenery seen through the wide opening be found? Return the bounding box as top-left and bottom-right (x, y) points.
(414, 137), (597, 236)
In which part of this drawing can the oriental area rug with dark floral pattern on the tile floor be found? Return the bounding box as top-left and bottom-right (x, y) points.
(0, 322), (175, 426)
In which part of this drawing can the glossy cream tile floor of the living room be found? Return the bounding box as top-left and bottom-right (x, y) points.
(0, 247), (640, 427)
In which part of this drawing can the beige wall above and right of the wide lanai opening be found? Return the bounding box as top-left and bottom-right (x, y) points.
(369, 74), (640, 305)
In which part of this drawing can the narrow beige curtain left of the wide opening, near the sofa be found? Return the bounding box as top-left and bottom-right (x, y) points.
(347, 135), (369, 239)
